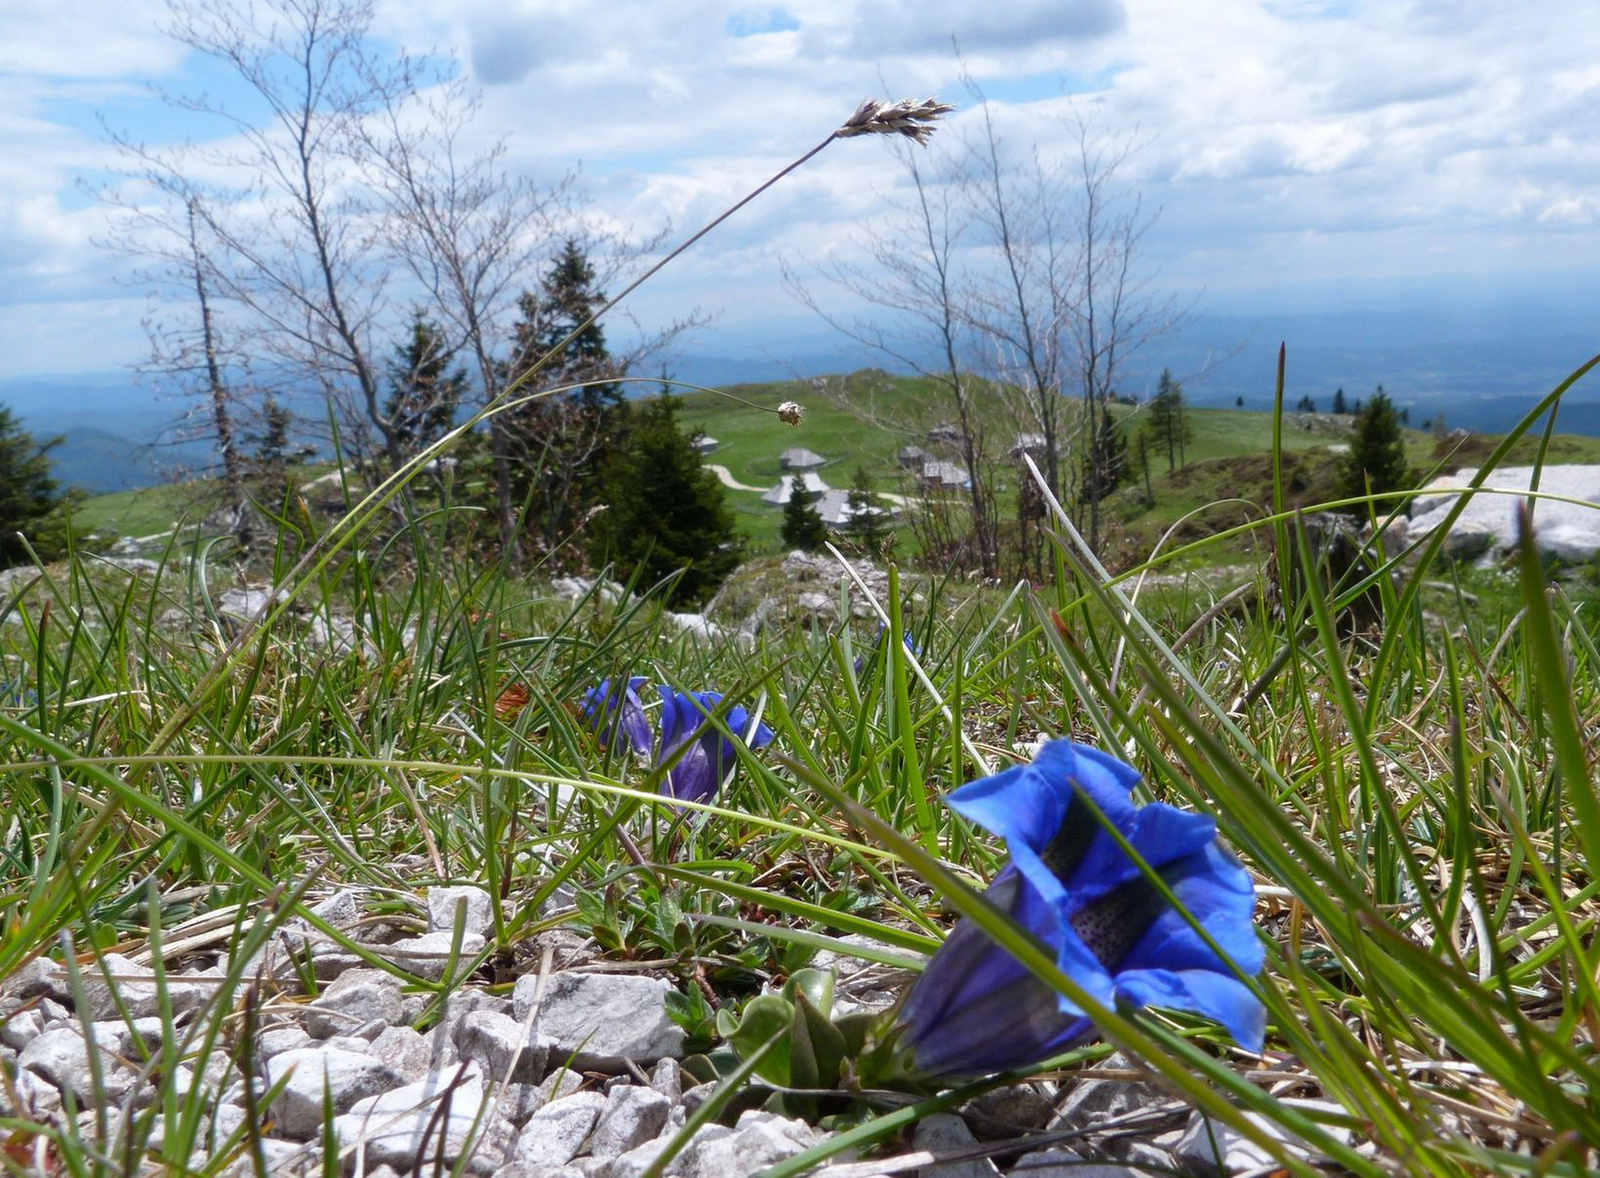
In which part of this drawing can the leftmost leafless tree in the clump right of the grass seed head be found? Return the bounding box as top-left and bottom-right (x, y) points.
(784, 146), (1000, 578)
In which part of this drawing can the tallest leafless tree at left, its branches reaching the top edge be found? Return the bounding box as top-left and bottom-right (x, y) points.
(146, 0), (424, 480)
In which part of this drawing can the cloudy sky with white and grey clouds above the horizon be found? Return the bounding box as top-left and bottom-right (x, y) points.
(0, 0), (1600, 387)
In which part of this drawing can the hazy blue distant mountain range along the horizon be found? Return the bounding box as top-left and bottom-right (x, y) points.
(0, 307), (1600, 493)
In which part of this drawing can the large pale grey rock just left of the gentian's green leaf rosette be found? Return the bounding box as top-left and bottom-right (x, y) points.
(512, 972), (683, 1072)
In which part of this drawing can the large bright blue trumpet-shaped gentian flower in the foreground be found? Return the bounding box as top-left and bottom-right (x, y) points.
(896, 741), (1266, 1076)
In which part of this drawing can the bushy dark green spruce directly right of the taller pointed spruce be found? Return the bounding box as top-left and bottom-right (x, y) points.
(590, 395), (741, 605)
